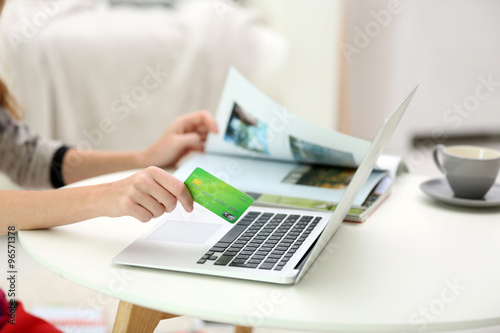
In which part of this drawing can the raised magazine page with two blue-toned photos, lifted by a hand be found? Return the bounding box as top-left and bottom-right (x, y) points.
(205, 68), (370, 168)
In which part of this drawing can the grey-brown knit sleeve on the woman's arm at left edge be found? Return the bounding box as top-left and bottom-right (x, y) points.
(0, 108), (62, 188)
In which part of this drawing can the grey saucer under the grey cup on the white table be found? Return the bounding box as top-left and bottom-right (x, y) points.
(420, 178), (500, 207)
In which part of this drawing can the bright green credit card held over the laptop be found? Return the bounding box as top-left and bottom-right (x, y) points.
(184, 168), (253, 223)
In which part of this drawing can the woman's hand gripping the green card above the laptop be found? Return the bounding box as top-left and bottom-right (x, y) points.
(96, 167), (193, 222)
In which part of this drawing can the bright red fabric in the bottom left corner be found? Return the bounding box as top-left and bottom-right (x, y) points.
(0, 292), (62, 333)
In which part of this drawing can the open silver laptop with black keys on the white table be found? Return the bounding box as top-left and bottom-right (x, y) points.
(113, 85), (418, 284)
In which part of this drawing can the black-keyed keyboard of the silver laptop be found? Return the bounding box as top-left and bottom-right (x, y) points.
(197, 211), (321, 271)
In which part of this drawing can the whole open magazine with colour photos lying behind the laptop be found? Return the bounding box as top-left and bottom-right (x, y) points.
(175, 69), (402, 222)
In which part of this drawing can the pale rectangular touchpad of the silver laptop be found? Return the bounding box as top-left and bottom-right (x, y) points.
(147, 221), (221, 244)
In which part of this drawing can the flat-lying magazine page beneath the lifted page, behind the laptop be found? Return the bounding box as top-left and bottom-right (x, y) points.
(174, 153), (387, 207)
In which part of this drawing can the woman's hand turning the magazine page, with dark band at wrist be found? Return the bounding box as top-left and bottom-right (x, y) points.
(139, 111), (218, 168)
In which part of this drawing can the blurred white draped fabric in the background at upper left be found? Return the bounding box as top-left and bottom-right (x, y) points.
(1, 0), (287, 149)
